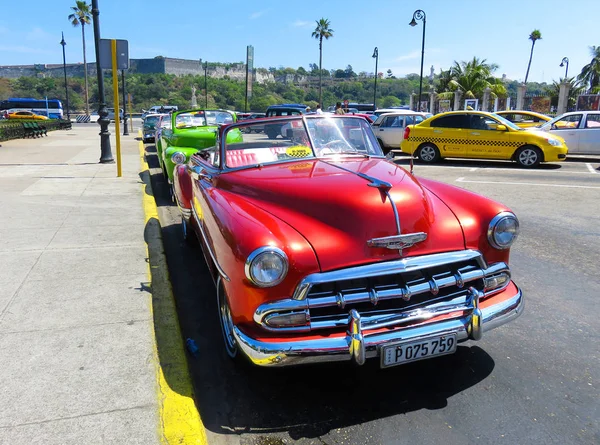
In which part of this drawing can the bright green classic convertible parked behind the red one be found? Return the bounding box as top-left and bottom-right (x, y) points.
(156, 110), (243, 184)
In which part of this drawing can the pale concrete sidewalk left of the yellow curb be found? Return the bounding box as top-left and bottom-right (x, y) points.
(0, 124), (204, 445)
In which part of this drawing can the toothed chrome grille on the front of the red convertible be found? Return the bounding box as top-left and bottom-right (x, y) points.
(254, 250), (510, 332)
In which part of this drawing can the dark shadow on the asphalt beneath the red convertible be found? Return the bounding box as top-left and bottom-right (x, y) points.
(147, 146), (494, 440)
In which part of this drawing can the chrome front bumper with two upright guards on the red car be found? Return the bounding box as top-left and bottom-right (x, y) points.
(233, 288), (524, 366)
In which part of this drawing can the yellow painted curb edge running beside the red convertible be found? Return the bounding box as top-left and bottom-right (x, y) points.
(138, 130), (208, 445)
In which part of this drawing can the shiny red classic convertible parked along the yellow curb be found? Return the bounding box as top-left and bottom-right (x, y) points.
(174, 115), (523, 367)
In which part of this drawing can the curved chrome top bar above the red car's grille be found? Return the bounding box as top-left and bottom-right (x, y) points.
(292, 250), (488, 300)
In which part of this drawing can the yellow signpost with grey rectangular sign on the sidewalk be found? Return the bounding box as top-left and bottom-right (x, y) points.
(98, 39), (129, 178)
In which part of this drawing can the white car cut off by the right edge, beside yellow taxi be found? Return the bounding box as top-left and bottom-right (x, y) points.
(532, 111), (600, 155)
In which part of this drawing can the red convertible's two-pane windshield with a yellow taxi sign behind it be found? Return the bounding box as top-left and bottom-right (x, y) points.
(220, 115), (383, 168)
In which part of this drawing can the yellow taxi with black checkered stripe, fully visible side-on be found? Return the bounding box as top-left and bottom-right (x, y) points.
(400, 111), (568, 167)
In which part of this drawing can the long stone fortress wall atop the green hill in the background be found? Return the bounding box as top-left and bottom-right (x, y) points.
(0, 56), (277, 83)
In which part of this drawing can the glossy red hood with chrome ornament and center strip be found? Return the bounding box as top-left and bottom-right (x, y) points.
(219, 158), (465, 271)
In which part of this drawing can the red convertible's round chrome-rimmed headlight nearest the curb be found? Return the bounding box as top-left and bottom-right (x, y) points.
(245, 246), (288, 287)
